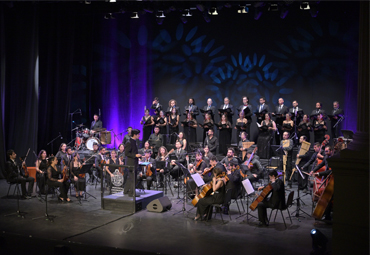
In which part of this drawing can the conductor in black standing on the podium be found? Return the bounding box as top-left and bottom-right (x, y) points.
(123, 129), (141, 197)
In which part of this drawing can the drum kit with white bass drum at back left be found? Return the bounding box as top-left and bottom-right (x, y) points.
(75, 124), (111, 151)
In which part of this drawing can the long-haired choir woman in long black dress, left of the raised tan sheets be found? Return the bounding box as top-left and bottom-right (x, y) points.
(257, 113), (276, 159)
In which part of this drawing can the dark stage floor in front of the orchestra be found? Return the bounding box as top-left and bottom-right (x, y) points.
(0, 180), (332, 254)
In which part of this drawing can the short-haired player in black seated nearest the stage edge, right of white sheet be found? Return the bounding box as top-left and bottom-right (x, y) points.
(257, 170), (285, 226)
